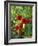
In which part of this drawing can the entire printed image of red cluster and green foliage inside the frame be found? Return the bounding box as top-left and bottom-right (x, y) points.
(9, 5), (32, 38)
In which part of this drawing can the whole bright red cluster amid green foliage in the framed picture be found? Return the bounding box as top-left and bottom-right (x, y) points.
(16, 15), (31, 31)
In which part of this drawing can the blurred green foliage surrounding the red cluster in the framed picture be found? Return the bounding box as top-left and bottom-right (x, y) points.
(9, 5), (32, 38)
